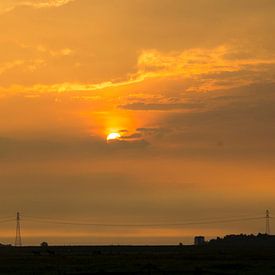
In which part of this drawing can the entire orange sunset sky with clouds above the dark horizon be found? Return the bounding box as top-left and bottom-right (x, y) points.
(0, 0), (275, 244)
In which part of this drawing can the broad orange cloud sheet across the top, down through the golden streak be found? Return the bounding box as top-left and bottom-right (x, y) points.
(0, 0), (275, 92)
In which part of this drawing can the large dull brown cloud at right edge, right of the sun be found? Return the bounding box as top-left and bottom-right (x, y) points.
(152, 84), (275, 158)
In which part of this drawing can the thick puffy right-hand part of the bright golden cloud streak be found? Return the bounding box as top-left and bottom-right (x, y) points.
(135, 45), (275, 90)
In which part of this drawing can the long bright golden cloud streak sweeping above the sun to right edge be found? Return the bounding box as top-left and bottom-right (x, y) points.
(1, 46), (275, 95)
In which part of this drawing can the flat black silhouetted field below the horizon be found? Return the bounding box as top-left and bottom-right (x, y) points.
(0, 245), (275, 274)
